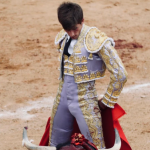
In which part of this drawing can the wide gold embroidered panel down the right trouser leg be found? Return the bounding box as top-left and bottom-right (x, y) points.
(78, 82), (105, 149)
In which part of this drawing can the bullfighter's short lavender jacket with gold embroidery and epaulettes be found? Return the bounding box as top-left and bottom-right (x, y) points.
(55, 25), (127, 108)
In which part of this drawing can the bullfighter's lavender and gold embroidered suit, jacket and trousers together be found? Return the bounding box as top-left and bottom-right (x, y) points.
(49, 25), (127, 148)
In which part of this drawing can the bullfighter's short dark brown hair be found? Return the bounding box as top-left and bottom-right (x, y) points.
(57, 2), (83, 31)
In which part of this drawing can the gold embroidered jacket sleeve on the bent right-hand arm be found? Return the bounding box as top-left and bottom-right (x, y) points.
(98, 41), (127, 108)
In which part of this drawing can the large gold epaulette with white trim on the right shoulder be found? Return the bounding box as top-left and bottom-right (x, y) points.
(84, 27), (115, 53)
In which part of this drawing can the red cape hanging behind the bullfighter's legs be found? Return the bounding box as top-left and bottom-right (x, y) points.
(39, 104), (132, 150)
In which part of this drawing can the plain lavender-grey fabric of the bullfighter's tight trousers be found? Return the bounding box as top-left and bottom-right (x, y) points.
(50, 75), (103, 148)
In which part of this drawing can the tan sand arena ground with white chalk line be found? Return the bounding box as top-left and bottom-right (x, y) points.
(0, 0), (150, 150)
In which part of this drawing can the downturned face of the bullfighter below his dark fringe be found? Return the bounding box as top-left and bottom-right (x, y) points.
(65, 21), (83, 39)
